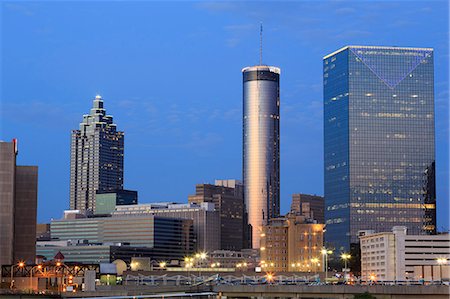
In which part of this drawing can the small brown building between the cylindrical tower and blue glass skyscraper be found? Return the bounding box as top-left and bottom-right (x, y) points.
(291, 194), (325, 223)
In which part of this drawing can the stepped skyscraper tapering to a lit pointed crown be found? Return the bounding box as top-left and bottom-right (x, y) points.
(70, 95), (124, 211)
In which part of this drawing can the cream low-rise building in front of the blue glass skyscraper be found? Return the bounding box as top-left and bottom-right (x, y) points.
(360, 226), (450, 281)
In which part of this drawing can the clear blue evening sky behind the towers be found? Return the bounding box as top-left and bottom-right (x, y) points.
(0, 1), (449, 228)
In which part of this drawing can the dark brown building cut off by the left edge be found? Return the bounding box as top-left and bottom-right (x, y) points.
(0, 139), (38, 265)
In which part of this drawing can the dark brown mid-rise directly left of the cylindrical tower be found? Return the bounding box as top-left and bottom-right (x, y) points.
(188, 181), (245, 250)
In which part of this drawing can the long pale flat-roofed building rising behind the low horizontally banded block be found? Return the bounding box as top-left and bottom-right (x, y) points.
(112, 202), (220, 252)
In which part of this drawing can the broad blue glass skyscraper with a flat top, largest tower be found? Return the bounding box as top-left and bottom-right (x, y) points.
(323, 46), (436, 250)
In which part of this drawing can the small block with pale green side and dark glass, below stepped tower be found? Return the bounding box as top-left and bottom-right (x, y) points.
(95, 190), (138, 215)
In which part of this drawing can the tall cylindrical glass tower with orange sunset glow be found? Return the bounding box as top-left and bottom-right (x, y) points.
(242, 65), (280, 248)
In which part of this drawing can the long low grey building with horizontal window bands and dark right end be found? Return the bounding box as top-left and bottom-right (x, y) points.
(47, 213), (195, 262)
